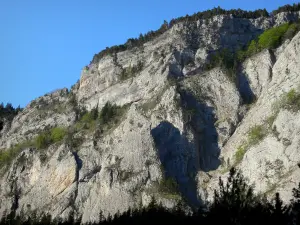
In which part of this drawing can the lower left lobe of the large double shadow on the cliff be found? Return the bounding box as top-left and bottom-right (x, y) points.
(151, 121), (200, 207)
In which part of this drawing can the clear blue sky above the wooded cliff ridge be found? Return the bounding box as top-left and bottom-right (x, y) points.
(0, 0), (298, 107)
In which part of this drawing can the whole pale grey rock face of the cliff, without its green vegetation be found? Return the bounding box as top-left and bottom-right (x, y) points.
(0, 10), (300, 222)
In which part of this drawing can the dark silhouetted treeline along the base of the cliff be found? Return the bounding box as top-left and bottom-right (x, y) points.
(0, 168), (300, 225)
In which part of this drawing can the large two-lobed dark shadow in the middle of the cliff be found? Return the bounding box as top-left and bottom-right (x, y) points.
(151, 90), (221, 207)
